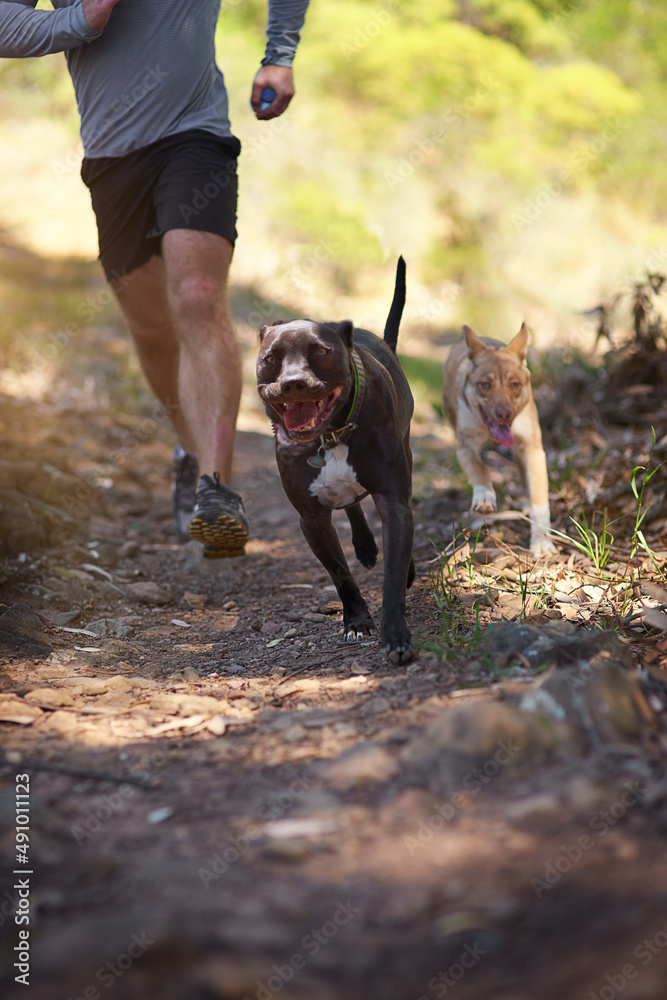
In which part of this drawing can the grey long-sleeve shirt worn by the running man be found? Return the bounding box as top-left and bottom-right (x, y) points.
(0, 0), (308, 158)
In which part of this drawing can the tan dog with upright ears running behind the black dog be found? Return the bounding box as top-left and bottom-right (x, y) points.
(443, 323), (555, 555)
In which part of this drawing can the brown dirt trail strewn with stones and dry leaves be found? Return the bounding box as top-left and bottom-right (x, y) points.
(0, 354), (667, 1000)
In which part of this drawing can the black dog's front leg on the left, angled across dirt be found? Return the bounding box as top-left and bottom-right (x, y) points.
(299, 505), (375, 642)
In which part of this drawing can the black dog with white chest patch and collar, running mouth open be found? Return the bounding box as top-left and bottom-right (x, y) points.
(257, 257), (415, 663)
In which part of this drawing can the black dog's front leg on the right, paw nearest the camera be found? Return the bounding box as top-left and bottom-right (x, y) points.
(373, 494), (414, 663)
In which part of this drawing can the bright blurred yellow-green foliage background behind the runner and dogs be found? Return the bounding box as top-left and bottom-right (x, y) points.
(0, 0), (667, 402)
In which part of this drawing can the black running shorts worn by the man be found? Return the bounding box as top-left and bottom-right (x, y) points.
(81, 129), (241, 281)
